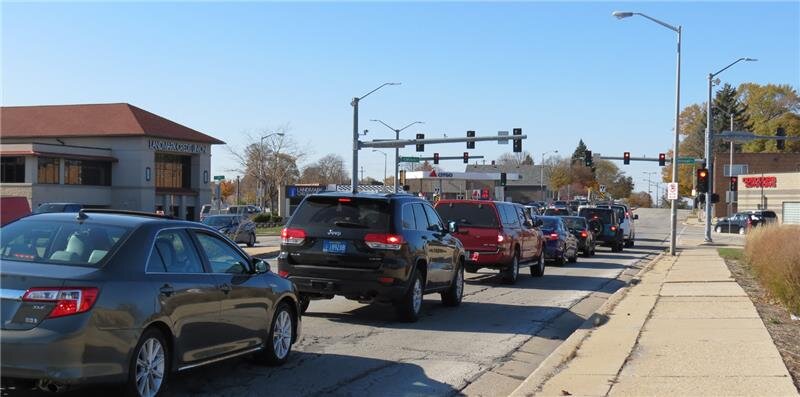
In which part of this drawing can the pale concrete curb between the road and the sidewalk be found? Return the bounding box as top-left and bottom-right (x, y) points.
(510, 252), (666, 397)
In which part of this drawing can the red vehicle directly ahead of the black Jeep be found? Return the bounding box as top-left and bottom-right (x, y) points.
(436, 200), (544, 284)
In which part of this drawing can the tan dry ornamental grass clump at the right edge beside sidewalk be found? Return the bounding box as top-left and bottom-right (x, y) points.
(744, 225), (800, 314)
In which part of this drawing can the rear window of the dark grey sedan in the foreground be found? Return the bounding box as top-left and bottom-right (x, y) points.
(0, 219), (130, 266)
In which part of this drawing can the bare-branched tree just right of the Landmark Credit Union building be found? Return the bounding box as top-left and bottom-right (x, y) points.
(227, 125), (306, 209)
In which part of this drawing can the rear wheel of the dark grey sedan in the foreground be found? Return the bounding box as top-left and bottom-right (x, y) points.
(125, 328), (171, 397)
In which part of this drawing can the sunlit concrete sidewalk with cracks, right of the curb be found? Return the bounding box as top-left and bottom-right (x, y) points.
(513, 246), (798, 396)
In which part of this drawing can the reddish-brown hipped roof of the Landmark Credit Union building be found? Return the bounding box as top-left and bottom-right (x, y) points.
(0, 103), (225, 144)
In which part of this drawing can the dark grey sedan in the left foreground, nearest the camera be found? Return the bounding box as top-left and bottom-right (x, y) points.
(0, 210), (301, 397)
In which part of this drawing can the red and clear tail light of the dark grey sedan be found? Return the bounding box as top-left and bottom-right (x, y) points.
(22, 287), (99, 318)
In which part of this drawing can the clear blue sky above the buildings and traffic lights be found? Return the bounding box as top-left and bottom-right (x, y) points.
(0, 1), (800, 190)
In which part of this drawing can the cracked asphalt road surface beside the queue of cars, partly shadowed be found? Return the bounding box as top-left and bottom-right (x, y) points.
(3, 209), (687, 396)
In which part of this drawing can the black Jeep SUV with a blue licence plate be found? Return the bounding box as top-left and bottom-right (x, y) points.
(278, 193), (464, 321)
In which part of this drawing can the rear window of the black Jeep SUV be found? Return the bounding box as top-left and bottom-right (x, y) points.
(289, 196), (391, 232)
